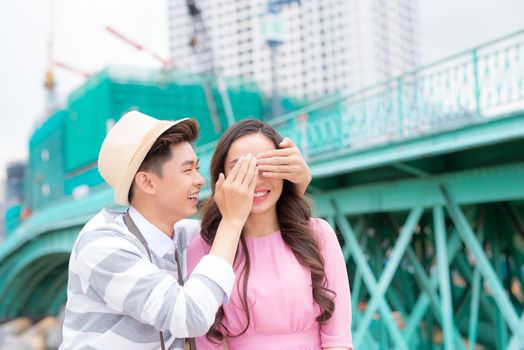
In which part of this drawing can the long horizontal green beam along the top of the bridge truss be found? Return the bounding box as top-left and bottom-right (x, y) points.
(313, 162), (524, 215)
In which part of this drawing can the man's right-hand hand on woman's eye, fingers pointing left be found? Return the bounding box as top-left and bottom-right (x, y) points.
(257, 137), (311, 194)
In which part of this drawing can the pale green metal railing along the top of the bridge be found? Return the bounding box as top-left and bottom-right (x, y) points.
(271, 30), (524, 160)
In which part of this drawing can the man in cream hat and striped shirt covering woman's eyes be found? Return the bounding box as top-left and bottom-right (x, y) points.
(60, 112), (311, 350)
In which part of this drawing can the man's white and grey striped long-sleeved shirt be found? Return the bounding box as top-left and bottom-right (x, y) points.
(60, 207), (235, 350)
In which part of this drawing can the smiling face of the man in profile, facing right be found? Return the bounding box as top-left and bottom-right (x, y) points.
(152, 142), (204, 221)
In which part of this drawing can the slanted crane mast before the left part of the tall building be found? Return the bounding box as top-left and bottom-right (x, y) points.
(186, 0), (235, 132)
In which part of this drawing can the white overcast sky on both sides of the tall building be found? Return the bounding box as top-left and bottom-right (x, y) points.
(0, 0), (524, 179)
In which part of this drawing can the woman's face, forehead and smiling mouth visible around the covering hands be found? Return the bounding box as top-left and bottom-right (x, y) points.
(224, 133), (284, 214)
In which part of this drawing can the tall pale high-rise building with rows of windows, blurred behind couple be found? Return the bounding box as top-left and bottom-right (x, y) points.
(169, 0), (419, 99)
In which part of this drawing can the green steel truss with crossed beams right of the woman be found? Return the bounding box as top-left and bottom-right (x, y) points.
(314, 163), (524, 349)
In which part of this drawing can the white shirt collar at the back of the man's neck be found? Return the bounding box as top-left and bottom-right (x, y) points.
(129, 206), (175, 257)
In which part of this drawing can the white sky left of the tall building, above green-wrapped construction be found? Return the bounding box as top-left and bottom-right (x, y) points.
(0, 0), (168, 179)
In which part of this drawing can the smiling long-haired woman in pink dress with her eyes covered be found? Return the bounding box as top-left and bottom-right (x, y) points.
(188, 119), (352, 350)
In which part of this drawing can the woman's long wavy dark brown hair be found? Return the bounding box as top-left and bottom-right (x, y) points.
(201, 119), (335, 342)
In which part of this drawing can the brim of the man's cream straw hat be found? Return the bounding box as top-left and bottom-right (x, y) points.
(115, 118), (189, 205)
